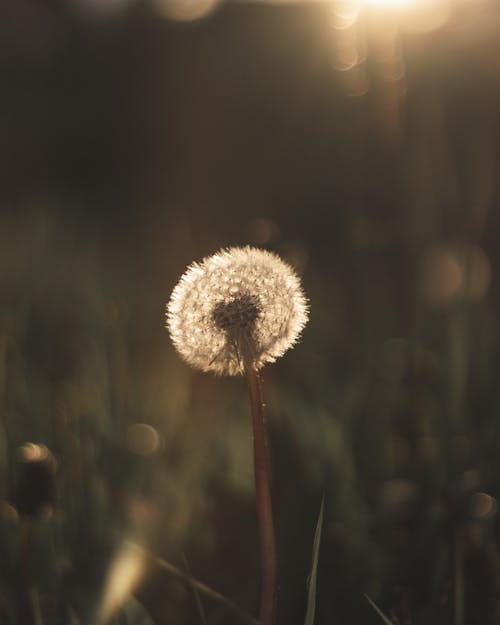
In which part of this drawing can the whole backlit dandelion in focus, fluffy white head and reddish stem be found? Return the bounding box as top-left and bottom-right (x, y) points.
(167, 247), (308, 625)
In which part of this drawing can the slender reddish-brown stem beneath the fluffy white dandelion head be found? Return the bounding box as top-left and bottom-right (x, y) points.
(245, 364), (277, 625)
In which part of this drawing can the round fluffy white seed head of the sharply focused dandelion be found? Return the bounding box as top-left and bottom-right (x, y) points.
(167, 247), (308, 375)
